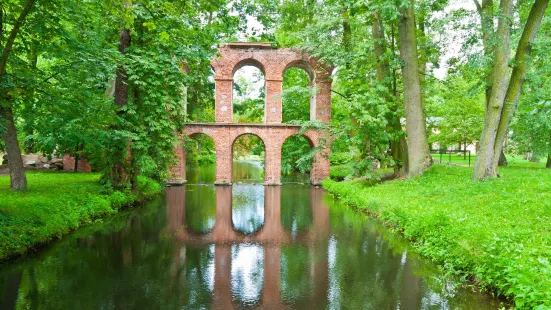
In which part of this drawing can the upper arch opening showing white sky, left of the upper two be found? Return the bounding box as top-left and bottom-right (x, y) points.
(232, 62), (266, 123)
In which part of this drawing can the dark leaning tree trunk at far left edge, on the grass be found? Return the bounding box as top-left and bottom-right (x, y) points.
(0, 108), (27, 192)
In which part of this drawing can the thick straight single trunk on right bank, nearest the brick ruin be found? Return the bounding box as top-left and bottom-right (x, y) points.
(398, 0), (432, 177)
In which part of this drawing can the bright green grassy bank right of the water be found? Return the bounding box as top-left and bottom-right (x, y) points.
(323, 165), (551, 309)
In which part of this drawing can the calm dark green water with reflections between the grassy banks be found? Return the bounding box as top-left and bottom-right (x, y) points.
(0, 162), (497, 309)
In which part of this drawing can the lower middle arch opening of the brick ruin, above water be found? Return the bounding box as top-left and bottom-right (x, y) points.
(232, 134), (266, 183)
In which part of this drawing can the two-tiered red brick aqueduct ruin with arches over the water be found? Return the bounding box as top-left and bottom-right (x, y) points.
(169, 42), (332, 185)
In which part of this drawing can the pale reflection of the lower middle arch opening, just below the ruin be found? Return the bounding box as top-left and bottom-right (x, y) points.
(232, 184), (264, 234)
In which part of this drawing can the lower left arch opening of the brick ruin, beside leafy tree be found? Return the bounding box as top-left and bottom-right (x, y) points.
(186, 133), (216, 184)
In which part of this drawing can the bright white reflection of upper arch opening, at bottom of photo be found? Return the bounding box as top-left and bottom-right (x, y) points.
(231, 244), (264, 307)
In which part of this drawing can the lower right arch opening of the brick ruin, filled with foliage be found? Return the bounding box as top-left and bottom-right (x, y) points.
(281, 135), (314, 183)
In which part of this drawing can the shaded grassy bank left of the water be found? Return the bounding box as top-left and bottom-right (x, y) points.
(0, 172), (162, 261)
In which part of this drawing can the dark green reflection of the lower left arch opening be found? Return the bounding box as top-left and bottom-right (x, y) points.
(185, 185), (216, 234)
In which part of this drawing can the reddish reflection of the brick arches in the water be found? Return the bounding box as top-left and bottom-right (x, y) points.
(167, 186), (329, 309)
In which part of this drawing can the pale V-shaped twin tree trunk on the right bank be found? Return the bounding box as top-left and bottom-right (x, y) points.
(473, 0), (549, 180)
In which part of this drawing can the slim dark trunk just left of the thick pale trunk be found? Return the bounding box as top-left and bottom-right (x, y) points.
(371, 11), (408, 177)
